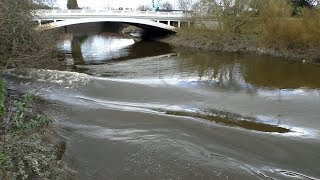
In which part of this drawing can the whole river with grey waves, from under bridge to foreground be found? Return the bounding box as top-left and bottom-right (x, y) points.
(3, 33), (320, 180)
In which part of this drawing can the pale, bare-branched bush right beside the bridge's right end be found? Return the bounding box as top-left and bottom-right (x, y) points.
(193, 0), (265, 36)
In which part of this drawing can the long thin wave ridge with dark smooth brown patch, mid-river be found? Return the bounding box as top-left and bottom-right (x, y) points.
(76, 96), (291, 133)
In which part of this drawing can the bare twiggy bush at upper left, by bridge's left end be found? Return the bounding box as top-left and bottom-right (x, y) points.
(0, 0), (56, 70)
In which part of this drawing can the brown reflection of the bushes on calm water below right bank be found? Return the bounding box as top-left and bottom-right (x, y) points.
(178, 50), (320, 90)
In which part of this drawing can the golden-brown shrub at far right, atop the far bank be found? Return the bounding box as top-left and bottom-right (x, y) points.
(260, 0), (320, 48)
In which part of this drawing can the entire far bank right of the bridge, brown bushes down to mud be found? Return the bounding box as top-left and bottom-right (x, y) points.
(162, 0), (320, 63)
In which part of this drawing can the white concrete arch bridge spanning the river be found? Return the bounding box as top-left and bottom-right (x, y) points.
(34, 10), (190, 32)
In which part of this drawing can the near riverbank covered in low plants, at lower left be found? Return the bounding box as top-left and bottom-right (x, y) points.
(0, 85), (72, 180)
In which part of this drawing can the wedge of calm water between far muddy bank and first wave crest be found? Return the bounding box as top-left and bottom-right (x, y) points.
(78, 48), (320, 97)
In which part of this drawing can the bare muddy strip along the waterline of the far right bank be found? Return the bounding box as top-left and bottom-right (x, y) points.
(157, 33), (320, 65)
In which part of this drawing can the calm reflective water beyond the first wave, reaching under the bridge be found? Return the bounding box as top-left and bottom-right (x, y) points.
(59, 34), (320, 92)
